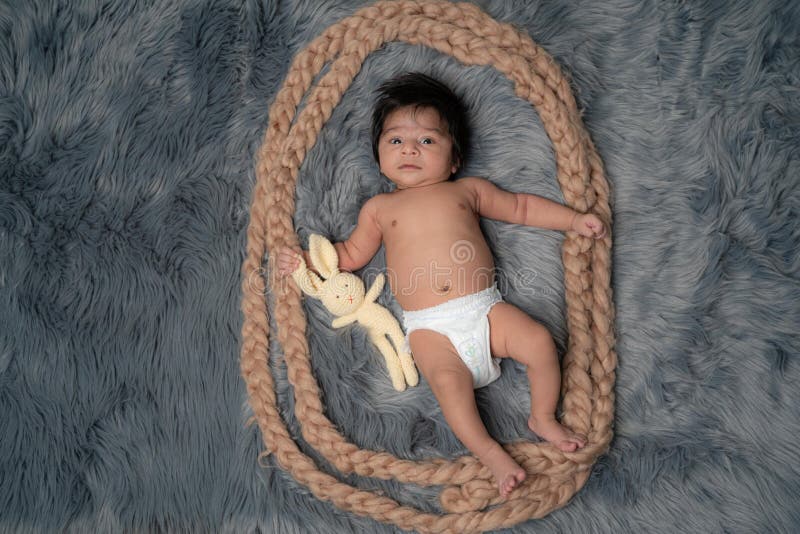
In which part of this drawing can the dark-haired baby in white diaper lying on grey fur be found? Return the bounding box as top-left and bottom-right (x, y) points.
(277, 73), (605, 496)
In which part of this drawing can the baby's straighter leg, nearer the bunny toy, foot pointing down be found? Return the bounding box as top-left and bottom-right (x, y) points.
(409, 330), (525, 497)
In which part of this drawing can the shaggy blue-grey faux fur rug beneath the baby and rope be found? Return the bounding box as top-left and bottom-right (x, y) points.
(0, 0), (800, 533)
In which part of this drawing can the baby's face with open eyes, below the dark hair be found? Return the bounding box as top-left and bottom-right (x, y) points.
(378, 107), (457, 189)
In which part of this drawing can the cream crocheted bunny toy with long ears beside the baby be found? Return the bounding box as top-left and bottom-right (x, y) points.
(292, 234), (419, 391)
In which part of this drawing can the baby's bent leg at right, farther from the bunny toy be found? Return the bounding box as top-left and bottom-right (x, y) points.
(489, 302), (586, 452)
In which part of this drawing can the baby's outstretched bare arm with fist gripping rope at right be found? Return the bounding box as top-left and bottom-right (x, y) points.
(459, 178), (606, 239)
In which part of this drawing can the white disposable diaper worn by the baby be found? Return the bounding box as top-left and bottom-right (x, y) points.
(403, 285), (503, 388)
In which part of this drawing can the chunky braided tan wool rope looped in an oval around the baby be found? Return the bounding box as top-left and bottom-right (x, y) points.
(241, 0), (616, 533)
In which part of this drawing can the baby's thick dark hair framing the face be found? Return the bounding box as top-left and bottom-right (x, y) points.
(372, 72), (469, 174)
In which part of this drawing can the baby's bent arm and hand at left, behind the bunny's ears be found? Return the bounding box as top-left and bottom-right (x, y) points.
(277, 197), (382, 276)
